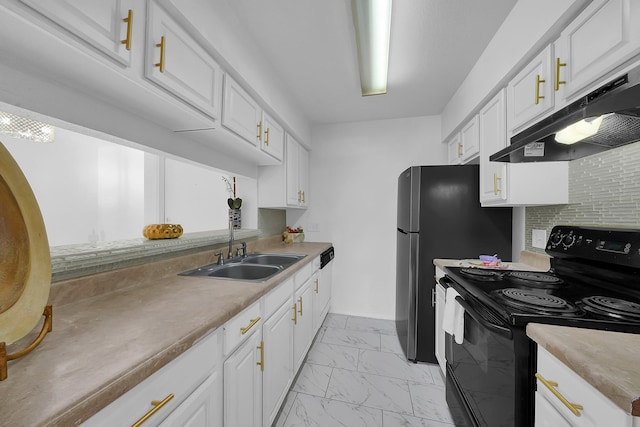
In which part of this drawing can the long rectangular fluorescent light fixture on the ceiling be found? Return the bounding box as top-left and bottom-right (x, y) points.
(351, 0), (391, 96)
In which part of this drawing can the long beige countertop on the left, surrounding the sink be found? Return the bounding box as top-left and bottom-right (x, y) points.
(0, 240), (331, 427)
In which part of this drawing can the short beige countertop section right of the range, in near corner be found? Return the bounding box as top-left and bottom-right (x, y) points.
(527, 323), (640, 416)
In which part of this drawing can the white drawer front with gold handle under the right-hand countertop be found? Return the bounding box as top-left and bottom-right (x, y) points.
(537, 346), (631, 427)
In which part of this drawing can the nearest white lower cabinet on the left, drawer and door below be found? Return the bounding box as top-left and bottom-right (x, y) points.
(83, 331), (223, 427)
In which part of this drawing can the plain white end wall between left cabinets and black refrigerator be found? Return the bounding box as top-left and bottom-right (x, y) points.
(302, 117), (446, 319)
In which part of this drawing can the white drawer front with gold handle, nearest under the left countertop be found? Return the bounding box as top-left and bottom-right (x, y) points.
(83, 331), (221, 427)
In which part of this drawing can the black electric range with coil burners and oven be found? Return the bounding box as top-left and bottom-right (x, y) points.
(441, 226), (640, 427)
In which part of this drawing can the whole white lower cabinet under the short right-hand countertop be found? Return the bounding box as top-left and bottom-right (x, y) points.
(535, 346), (637, 427)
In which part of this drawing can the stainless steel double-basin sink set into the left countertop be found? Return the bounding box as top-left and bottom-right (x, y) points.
(179, 253), (306, 282)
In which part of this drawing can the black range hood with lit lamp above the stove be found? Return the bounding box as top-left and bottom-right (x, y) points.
(489, 67), (640, 163)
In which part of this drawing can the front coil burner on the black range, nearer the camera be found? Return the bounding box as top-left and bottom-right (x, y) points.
(496, 288), (582, 316)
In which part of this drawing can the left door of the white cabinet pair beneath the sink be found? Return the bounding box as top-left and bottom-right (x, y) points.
(262, 300), (294, 427)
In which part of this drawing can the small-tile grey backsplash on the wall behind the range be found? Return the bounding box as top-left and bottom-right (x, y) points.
(525, 143), (640, 253)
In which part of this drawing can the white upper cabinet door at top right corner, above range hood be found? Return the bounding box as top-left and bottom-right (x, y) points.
(558, 0), (640, 99)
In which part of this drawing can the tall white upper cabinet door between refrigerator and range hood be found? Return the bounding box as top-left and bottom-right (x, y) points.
(479, 89), (507, 202)
